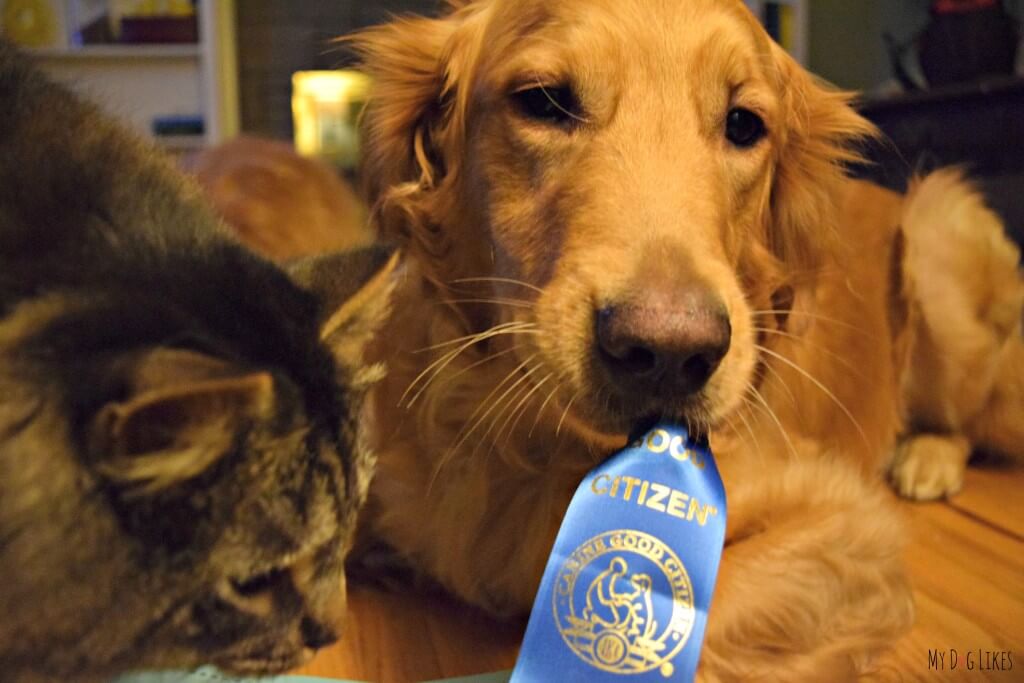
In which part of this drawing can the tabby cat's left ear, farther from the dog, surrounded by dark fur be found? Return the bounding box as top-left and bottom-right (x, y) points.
(90, 349), (273, 496)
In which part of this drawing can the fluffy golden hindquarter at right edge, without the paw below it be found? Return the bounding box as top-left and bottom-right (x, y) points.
(902, 169), (1024, 458)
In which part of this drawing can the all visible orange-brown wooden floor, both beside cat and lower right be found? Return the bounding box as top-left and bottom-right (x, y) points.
(301, 466), (1024, 683)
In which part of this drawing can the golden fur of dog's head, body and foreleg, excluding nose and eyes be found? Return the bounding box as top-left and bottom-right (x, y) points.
(355, 0), (1015, 681)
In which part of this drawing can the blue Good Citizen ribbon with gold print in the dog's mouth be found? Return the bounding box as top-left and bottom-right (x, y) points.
(511, 424), (725, 683)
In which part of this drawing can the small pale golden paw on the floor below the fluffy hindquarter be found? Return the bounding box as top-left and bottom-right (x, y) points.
(889, 434), (971, 501)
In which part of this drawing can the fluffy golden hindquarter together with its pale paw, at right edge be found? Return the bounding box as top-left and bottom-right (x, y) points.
(891, 171), (1024, 500)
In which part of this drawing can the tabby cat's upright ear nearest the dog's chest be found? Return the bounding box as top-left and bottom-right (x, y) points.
(289, 246), (399, 368)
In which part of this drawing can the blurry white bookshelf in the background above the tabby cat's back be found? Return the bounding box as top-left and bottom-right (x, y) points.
(0, 0), (239, 152)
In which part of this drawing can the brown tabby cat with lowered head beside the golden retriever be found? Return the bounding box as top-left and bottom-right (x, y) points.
(0, 45), (395, 683)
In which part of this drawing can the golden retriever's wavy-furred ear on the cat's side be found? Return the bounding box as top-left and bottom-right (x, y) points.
(345, 0), (488, 268)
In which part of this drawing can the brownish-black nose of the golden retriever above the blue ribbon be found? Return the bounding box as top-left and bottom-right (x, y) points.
(596, 287), (732, 399)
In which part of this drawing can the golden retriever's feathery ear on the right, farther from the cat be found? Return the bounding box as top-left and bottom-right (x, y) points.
(769, 43), (879, 270)
